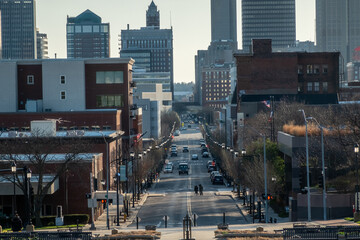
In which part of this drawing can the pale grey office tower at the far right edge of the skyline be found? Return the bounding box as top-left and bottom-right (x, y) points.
(316, 0), (360, 64)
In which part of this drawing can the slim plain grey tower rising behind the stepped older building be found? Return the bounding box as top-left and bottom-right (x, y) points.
(211, 0), (237, 45)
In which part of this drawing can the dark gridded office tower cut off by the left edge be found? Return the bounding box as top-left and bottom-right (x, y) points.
(0, 0), (37, 59)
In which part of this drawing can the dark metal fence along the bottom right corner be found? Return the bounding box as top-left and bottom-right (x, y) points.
(283, 226), (360, 240)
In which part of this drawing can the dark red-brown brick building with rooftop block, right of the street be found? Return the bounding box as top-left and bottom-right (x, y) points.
(234, 39), (339, 117)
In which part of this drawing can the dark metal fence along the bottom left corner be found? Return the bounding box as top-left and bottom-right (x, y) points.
(0, 232), (92, 240)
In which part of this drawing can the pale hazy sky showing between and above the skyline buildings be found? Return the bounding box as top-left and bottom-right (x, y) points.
(36, 0), (315, 82)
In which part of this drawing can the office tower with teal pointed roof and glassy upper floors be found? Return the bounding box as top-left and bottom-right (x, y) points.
(66, 9), (110, 58)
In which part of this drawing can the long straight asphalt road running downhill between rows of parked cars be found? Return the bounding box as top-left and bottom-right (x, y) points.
(131, 124), (246, 228)
